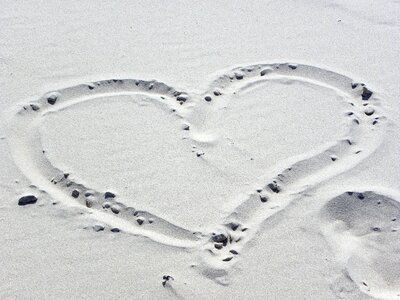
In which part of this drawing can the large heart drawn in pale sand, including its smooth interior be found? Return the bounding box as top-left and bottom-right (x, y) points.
(10, 63), (382, 270)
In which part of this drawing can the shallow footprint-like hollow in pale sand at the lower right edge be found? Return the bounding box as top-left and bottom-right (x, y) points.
(321, 191), (400, 299)
